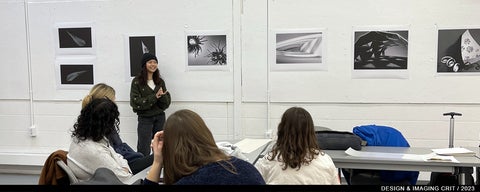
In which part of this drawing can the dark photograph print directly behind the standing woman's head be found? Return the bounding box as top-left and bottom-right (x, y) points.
(127, 36), (156, 77)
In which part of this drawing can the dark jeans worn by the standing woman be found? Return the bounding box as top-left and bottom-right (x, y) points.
(137, 112), (165, 156)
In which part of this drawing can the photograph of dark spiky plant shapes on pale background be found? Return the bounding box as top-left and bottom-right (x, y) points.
(186, 33), (228, 70)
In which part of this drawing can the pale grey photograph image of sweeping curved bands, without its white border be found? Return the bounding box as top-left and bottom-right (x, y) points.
(276, 32), (322, 64)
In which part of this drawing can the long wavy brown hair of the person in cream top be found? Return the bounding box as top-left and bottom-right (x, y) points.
(268, 107), (320, 170)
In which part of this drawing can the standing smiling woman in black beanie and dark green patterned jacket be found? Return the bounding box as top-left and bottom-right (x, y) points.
(130, 53), (171, 156)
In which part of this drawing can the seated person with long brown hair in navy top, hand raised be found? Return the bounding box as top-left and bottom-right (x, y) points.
(144, 109), (265, 185)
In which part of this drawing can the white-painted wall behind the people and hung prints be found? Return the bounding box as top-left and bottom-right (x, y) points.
(0, 0), (480, 181)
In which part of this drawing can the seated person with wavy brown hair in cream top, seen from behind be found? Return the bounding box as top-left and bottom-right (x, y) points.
(255, 107), (340, 185)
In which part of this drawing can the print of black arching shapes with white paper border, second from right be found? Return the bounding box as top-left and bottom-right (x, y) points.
(351, 26), (409, 79)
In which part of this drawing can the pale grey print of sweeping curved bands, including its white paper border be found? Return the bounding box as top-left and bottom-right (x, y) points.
(270, 29), (326, 71)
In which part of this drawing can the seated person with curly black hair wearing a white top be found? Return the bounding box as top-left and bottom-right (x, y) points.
(67, 98), (132, 182)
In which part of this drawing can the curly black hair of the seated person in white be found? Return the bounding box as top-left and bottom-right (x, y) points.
(72, 98), (120, 142)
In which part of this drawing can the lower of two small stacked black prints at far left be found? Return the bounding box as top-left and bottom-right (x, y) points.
(60, 65), (93, 85)
